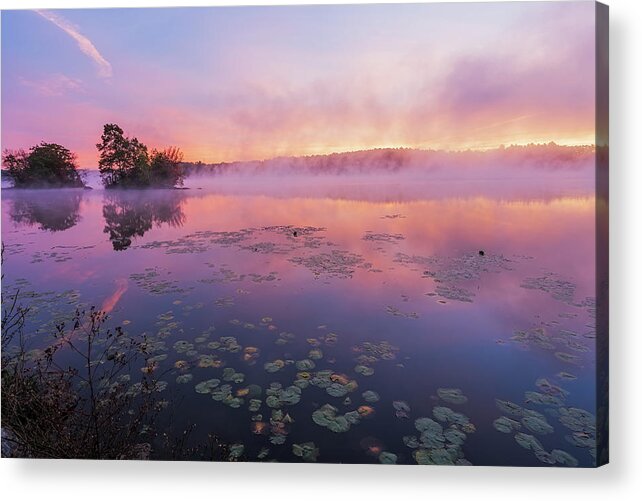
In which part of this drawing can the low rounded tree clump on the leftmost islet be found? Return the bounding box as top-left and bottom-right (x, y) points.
(2, 142), (84, 188)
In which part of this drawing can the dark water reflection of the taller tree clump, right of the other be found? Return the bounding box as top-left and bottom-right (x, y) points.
(103, 190), (185, 251)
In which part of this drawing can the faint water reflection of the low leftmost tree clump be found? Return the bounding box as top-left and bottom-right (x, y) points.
(9, 189), (84, 231)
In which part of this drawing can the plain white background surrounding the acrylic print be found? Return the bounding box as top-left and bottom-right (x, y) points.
(0, 0), (642, 501)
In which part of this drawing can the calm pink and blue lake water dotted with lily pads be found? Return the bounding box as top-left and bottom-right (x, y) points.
(2, 179), (595, 466)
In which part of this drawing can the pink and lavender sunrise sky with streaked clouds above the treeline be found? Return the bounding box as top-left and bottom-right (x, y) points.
(1, 1), (595, 168)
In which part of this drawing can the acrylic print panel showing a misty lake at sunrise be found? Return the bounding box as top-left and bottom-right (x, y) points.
(2, 2), (608, 467)
